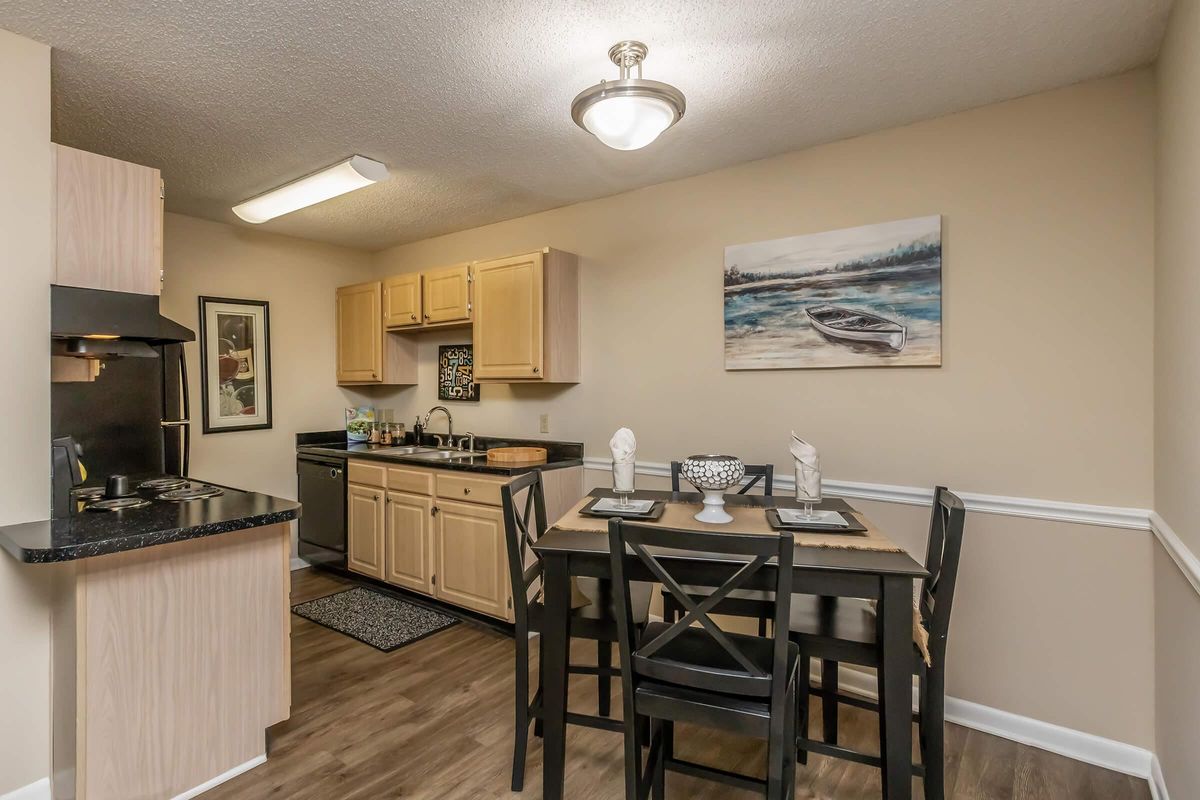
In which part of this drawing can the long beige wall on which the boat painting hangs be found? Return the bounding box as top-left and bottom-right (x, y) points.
(367, 71), (1154, 747)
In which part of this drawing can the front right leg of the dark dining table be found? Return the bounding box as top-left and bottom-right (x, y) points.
(877, 576), (913, 800)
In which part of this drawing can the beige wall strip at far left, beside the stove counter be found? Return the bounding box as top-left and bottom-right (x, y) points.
(0, 30), (52, 795)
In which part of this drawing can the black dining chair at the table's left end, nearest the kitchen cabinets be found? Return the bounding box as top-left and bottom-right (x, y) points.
(500, 470), (653, 792)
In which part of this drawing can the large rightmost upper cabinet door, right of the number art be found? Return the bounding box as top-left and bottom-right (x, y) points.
(473, 252), (544, 380)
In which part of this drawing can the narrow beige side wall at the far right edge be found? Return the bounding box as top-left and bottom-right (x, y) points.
(1154, 0), (1200, 798)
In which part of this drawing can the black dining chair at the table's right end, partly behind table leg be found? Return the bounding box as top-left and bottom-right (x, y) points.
(791, 486), (966, 800)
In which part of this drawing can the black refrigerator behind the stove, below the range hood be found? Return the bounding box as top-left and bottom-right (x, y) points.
(50, 343), (191, 483)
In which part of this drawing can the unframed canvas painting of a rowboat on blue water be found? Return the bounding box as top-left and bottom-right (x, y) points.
(725, 216), (942, 369)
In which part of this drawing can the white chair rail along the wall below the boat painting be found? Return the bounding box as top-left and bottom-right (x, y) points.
(583, 458), (1151, 530)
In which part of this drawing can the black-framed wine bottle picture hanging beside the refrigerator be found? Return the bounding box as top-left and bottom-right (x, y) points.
(200, 297), (271, 433)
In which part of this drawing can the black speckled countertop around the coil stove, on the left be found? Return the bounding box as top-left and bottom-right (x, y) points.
(0, 485), (300, 564)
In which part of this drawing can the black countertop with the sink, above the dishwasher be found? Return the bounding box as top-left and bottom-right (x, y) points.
(296, 431), (583, 475)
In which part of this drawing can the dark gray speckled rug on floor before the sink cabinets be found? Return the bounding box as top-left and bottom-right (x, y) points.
(292, 587), (458, 652)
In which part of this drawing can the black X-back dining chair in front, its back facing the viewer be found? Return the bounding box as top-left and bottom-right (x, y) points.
(608, 519), (799, 800)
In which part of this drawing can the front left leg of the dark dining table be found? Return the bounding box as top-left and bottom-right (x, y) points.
(541, 554), (571, 800)
